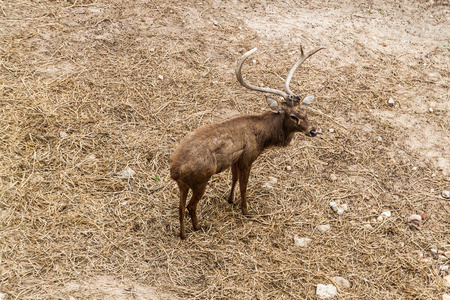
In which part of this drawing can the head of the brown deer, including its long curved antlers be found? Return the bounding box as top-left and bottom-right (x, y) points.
(236, 46), (325, 136)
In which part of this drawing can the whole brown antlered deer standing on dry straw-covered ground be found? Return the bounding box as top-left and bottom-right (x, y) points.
(170, 47), (325, 239)
